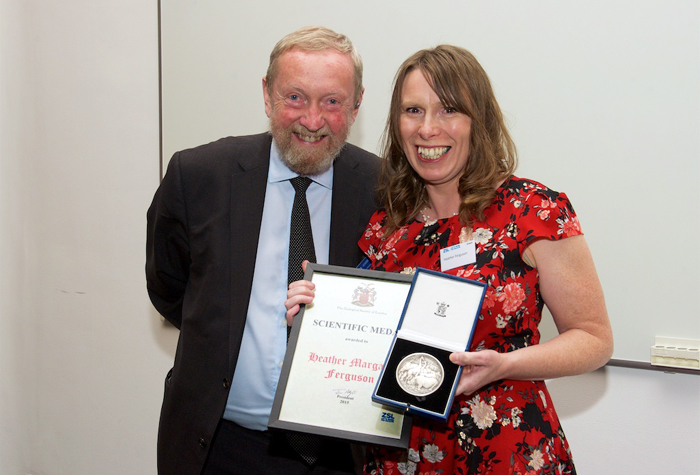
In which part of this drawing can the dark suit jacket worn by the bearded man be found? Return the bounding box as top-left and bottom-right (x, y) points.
(146, 134), (378, 475)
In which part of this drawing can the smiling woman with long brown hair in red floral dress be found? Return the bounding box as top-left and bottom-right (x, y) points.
(287, 45), (613, 475)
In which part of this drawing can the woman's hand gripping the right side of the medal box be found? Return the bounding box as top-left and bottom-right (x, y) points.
(450, 350), (507, 394)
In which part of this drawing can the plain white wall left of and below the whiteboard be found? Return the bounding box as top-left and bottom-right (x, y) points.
(0, 0), (700, 475)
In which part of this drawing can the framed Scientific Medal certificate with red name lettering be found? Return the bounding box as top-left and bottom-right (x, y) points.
(268, 264), (412, 447)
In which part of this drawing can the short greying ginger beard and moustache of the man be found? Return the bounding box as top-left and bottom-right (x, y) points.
(270, 120), (350, 175)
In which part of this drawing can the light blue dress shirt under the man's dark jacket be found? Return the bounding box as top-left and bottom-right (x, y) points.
(224, 141), (333, 430)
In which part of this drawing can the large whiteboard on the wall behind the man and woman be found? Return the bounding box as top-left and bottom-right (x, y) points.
(160, 0), (700, 362)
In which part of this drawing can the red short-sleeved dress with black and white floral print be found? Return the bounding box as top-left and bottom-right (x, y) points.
(359, 177), (582, 475)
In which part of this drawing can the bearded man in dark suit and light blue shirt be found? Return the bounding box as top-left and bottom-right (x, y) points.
(146, 27), (378, 475)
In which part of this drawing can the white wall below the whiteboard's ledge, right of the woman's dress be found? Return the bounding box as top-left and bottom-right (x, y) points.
(547, 367), (700, 475)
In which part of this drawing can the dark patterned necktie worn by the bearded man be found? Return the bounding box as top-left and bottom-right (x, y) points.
(287, 176), (321, 465)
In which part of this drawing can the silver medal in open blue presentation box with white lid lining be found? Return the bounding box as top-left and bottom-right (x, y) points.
(372, 268), (486, 421)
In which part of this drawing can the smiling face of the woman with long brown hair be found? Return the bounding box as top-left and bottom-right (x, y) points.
(399, 69), (472, 192)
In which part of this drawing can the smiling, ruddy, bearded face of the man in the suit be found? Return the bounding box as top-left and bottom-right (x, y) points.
(263, 49), (360, 175)
